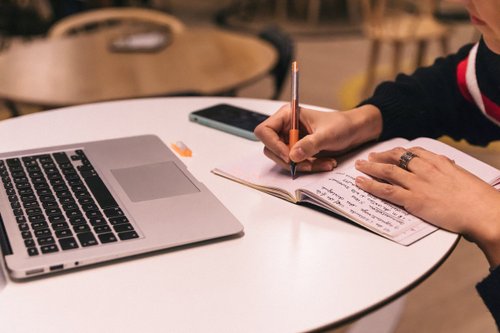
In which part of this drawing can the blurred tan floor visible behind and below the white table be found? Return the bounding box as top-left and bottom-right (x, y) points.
(0, 0), (500, 333)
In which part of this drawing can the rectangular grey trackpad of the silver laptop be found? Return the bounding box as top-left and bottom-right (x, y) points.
(111, 162), (200, 202)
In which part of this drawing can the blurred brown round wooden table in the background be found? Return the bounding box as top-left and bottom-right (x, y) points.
(0, 29), (277, 107)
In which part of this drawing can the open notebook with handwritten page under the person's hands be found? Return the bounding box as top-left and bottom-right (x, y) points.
(212, 138), (500, 245)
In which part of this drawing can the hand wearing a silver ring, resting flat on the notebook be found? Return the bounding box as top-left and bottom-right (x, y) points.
(356, 147), (500, 267)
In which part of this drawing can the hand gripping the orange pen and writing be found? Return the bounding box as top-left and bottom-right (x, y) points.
(255, 105), (382, 172)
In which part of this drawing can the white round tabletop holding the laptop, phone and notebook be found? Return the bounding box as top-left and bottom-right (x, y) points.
(0, 98), (458, 333)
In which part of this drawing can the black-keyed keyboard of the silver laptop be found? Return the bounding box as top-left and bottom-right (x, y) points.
(0, 149), (139, 256)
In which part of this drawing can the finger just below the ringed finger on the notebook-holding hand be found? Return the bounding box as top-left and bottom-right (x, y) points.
(355, 160), (416, 188)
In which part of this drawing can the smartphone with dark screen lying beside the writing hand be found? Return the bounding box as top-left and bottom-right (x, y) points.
(189, 104), (269, 141)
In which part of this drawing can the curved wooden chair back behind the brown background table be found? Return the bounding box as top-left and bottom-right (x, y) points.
(48, 7), (185, 38)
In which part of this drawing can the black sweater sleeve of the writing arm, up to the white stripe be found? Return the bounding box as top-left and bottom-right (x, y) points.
(361, 40), (500, 145)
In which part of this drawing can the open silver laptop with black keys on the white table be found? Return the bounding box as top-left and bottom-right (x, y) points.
(0, 135), (243, 279)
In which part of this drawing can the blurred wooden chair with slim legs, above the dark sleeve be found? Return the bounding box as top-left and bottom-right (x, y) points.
(361, 0), (449, 97)
